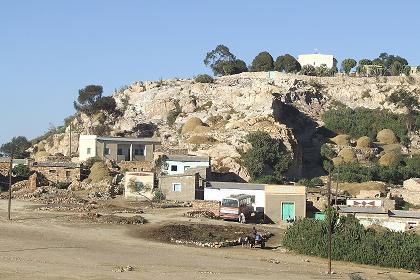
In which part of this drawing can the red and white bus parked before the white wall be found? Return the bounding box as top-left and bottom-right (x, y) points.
(220, 194), (255, 222)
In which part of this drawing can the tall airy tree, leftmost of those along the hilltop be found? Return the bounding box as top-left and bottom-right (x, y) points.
(204, 45), (240, 76)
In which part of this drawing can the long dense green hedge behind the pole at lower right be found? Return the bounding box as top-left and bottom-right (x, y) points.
(283, 214), (420, 271)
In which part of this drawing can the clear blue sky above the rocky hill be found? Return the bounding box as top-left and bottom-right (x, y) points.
(0, 0), (420, 147)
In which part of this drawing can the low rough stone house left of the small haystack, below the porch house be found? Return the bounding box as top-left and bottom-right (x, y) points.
(30, 162), (82, 183)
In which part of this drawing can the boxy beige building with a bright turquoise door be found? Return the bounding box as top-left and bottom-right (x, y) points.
(265, 185), (306, 223)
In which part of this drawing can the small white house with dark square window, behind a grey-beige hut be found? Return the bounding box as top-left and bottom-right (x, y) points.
(162, 155), (210, 175)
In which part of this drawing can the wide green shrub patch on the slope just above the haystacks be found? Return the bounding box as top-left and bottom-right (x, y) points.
(322, 107), (407, 139)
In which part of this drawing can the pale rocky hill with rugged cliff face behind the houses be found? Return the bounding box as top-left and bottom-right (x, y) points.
(34, 72), (420, 179)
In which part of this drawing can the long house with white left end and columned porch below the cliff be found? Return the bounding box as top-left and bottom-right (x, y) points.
(79, 135), (161, 162)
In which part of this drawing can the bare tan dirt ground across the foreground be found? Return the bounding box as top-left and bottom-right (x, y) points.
(0, 200), (420, 280)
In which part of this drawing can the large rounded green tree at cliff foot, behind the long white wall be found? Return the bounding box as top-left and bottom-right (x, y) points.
(244, 132), (290, 183)
